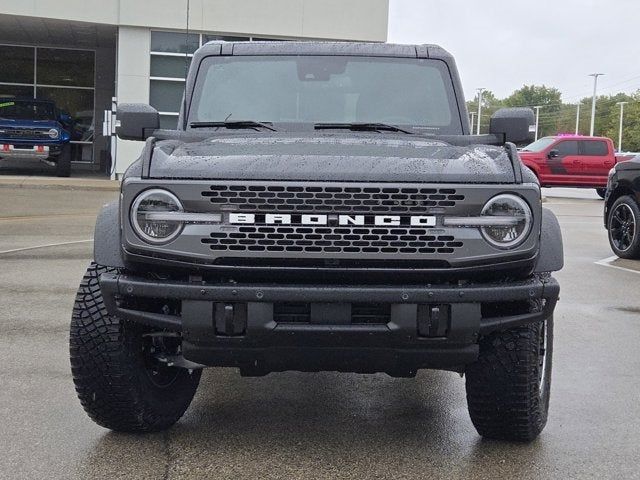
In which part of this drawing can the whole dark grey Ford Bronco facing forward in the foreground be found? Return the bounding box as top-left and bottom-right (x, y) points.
(70, 42), (563, 440)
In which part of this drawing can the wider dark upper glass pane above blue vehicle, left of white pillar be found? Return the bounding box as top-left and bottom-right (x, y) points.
(36, 48), (95, 87)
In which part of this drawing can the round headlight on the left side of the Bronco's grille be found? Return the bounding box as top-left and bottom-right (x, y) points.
(131, 188), (184, 243)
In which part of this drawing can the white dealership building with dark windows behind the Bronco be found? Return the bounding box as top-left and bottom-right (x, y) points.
(0, 0), (389, 175)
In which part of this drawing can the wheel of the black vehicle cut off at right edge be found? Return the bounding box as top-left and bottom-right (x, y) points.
(607, 195), (640, 260)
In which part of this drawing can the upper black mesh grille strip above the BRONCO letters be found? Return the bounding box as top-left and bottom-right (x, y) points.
(202, 184), (465, 214)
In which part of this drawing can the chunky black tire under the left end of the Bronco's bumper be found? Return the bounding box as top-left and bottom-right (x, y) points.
(70, 264), (201, 432)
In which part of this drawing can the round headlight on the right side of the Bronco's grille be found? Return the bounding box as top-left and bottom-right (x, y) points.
(481, 194), (532, 248)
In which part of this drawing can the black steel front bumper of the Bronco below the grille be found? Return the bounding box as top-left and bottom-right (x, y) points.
(100, 274), (559, 375)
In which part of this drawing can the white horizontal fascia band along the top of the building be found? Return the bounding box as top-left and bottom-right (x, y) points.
(0, 0), (389, 42)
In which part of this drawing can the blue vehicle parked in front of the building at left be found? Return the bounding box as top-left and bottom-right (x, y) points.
(0, 98), (71, 177)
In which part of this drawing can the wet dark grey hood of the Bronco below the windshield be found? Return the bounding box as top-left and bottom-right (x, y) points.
(149, 134), (515, 183)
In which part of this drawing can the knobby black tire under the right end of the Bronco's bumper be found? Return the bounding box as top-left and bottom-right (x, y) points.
(466, 317), (553, 442)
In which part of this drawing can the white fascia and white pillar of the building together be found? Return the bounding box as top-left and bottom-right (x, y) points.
(0, 0), (389, 175)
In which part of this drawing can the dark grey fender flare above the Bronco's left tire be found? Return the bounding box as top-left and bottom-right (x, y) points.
(93, 200), (124, 268)
